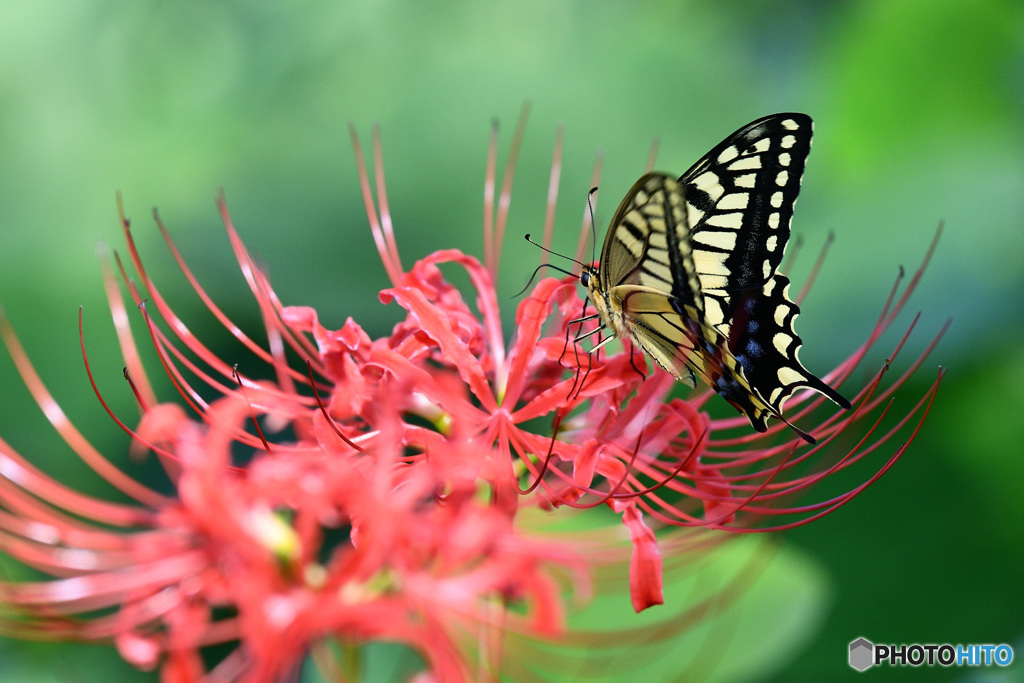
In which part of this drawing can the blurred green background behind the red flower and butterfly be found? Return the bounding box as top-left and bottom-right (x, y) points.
(0, 0), (1024, 681)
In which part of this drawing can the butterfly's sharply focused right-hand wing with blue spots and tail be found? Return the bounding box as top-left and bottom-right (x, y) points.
(680, 114), (849, 419)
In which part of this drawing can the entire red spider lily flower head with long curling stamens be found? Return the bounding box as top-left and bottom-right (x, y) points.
(0, 109), (941, 681)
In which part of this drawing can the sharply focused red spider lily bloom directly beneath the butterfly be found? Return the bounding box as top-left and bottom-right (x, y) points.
(353, 113), (944, 598)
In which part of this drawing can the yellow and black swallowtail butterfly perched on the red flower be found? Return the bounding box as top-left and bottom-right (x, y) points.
(580, 114), (850, 443)
